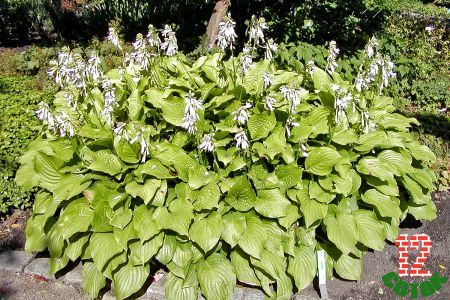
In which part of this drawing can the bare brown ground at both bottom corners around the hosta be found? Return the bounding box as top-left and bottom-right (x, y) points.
(0, 192), (450, 300)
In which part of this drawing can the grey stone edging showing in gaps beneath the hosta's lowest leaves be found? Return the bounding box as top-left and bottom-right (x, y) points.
(0, 250), (319, 300)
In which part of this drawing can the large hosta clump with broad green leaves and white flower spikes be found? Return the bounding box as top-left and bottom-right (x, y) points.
(16, 16), (436, 299)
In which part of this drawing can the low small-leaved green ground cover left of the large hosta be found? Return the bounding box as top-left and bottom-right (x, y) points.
(0, 76), (53, 217)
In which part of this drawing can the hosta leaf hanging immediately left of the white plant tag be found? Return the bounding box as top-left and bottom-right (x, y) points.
(287, 246), (317, 291)
